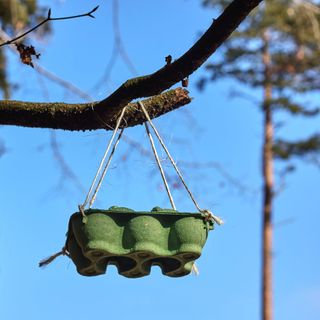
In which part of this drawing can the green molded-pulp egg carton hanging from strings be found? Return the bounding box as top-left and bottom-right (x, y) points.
(66, 207), (213, 278)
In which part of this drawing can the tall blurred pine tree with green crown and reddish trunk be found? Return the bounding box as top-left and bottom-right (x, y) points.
(199, 0), (320, 320)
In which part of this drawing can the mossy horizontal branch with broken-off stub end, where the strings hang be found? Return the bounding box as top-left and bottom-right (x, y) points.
(0, 88), (191, 130)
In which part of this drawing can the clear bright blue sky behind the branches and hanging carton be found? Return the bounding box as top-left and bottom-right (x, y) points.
(0, 0), (320, 320)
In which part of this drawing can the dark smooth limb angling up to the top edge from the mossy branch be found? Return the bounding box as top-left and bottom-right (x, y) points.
(97, 0), (262, 114)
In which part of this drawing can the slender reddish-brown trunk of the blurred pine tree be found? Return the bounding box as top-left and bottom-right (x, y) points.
(262, 32), (274, 320)
